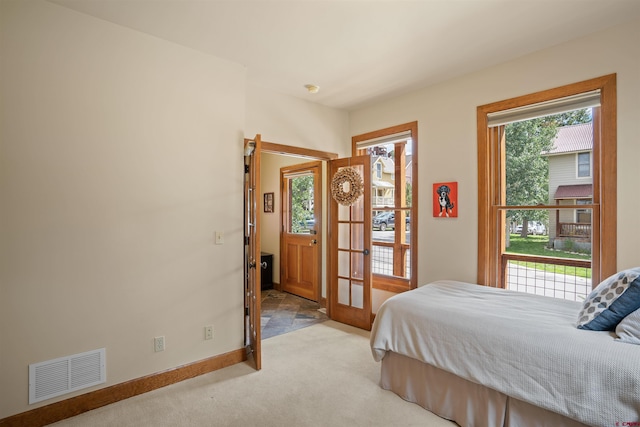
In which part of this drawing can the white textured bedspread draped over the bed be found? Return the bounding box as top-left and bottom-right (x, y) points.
(371, 280), (640, 427)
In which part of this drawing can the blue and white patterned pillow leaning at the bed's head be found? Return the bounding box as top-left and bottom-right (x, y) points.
(576, 267), (640, 331)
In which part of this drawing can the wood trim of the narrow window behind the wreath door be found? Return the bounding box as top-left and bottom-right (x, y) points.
(351, 121), (418, 293)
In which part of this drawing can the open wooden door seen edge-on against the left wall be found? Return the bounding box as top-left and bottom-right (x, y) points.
(244, 135), (262, 370)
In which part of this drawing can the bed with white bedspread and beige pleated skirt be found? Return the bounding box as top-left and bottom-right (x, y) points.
(371, 279), (640, 427)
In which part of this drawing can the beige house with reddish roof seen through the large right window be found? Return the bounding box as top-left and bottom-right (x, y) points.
(545, 123), (593, 249)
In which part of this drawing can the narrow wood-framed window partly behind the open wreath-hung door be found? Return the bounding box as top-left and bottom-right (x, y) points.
(352, 122), (418, 292)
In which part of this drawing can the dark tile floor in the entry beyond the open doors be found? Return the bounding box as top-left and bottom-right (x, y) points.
(260, 289), (328, 339)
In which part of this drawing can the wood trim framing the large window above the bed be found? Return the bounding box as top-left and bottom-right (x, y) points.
(477, 74), (617, 286)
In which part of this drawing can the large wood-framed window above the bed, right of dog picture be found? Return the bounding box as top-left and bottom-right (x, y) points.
(478, 75), (616, 300)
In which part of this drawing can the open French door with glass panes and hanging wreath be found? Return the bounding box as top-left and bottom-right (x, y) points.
(327, 155), (372, 330)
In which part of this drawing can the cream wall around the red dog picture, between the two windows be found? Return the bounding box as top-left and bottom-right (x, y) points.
(349, 20), (640, 298)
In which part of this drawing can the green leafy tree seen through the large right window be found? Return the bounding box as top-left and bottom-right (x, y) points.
(505, 109), (592, 237)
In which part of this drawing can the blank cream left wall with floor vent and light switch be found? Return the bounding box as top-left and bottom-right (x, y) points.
(0, 0), (246, 419)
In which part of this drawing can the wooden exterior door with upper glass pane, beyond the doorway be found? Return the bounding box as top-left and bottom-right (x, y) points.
(280, 162), (322, 301)
